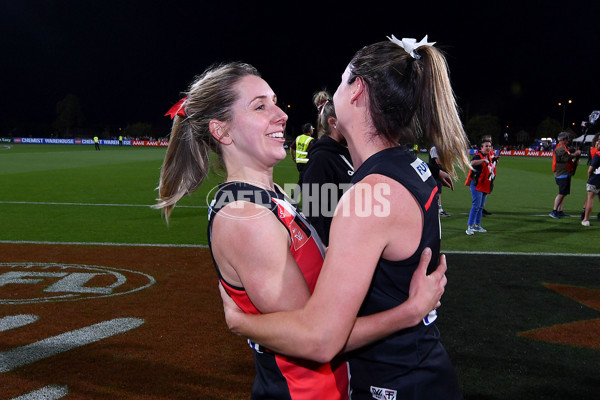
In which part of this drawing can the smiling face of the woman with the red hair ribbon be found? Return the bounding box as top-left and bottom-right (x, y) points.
(224, 75), (288, 167)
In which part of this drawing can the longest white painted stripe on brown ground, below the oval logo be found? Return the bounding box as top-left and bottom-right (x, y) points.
(0, 318), (144, 373)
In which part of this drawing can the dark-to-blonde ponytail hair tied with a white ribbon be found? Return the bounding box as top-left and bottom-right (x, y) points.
(348, 42), (470, 179)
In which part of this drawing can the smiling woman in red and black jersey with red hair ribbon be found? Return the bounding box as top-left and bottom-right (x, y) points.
(155, 63), (443, 400)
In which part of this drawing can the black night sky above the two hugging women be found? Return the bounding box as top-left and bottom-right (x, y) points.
(0, 0), (600, 136)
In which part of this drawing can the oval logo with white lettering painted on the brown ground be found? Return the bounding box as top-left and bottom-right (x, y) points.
(0, 262), (156, 304)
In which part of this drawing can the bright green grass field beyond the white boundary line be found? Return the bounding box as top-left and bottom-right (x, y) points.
(0, 144), (600, 254)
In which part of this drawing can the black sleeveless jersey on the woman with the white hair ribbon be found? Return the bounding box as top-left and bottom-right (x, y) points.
(348, 147), (462, 400)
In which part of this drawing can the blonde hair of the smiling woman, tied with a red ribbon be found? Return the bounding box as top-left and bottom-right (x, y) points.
(153, 62), (260, 222)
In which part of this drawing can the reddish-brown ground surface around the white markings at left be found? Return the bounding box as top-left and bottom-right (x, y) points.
(0, 244), (254, 400)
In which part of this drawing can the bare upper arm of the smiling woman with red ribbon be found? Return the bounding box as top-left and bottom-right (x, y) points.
(212, 202), (310, 313)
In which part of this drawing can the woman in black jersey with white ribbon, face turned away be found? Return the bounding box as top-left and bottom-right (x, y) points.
(225, 36), (469, 400)
